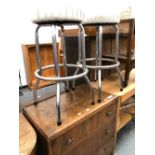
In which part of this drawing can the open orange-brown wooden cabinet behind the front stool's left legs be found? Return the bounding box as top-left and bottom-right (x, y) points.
(22, 43), (61, 89)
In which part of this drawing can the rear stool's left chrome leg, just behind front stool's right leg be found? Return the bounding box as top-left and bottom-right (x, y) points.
(72, 27), (82, 90)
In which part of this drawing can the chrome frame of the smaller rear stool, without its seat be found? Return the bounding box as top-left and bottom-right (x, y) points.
(72, 23), (123, 102)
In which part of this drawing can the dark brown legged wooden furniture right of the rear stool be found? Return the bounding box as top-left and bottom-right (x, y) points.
(103, 19), (135, 86)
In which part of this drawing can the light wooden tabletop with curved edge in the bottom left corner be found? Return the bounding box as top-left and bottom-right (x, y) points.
(19, 113), (37, 155)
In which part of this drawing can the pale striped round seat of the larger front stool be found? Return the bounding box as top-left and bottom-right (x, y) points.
(32, 0), (84, 24)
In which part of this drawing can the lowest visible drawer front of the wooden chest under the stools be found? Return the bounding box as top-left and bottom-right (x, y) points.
(93, 137), (115, 155)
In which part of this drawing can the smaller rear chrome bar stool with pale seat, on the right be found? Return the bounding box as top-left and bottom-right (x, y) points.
(82, 9), (123, 102)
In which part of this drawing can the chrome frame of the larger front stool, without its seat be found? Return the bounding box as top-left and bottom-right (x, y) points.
(33, 21), (95, 126)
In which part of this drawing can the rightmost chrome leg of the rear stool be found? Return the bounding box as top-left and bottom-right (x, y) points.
(115, 25), (123, 91)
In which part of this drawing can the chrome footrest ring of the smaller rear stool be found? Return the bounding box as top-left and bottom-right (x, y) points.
(85, 58), (120, 69)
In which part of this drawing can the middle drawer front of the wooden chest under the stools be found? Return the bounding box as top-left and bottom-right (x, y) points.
(63, 121), (115, 155)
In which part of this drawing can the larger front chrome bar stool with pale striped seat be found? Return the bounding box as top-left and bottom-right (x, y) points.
(32, 4), (94, 126)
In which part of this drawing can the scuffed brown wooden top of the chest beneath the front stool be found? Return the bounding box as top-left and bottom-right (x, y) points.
(24, 84), (117, 140)
